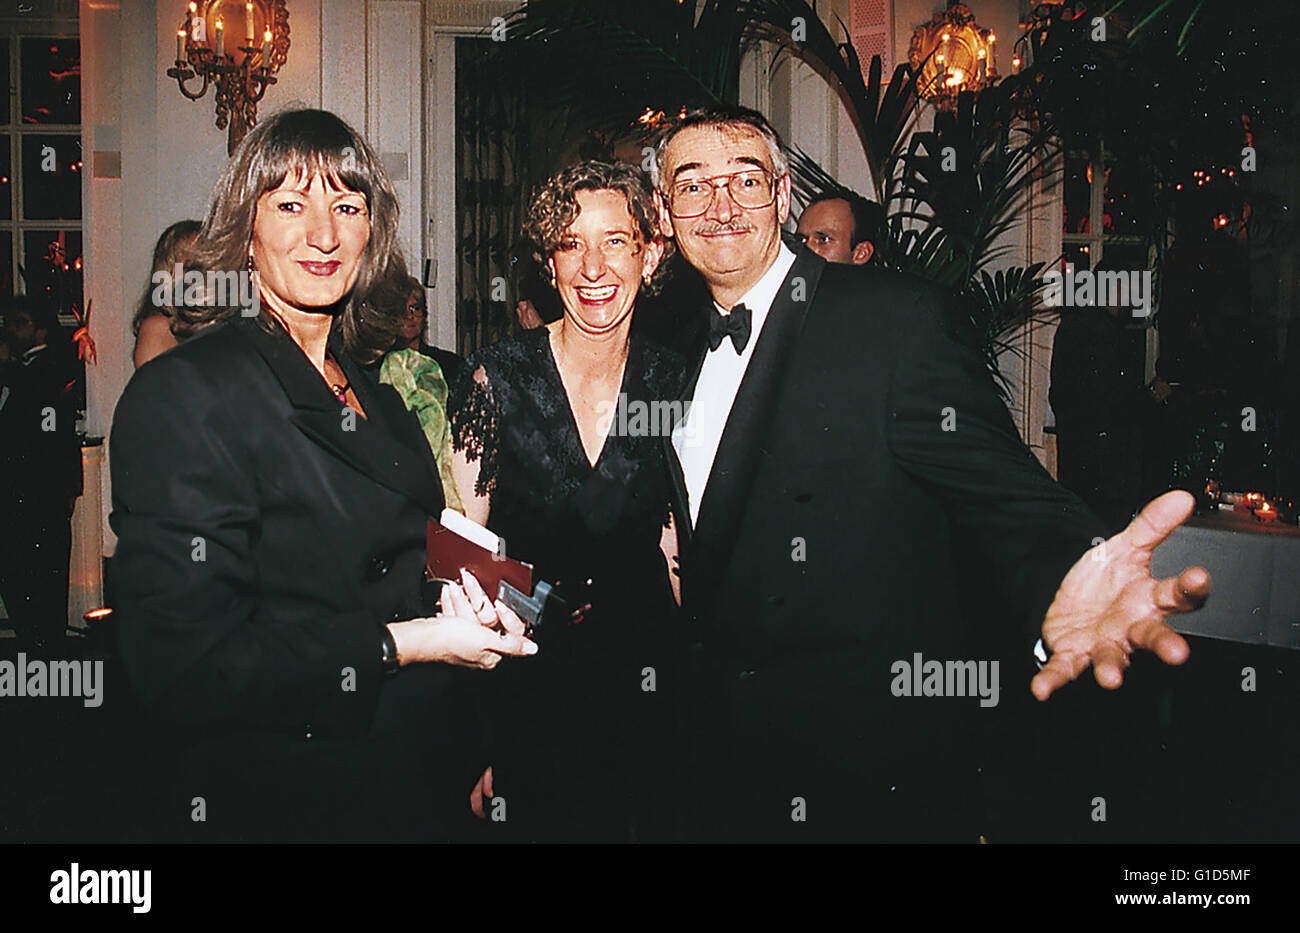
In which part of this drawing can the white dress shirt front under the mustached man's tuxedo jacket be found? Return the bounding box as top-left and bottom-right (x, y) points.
(672, 243), (794, 526)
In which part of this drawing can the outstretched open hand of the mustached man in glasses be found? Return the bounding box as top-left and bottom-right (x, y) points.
(1030, 490), (1210, 700)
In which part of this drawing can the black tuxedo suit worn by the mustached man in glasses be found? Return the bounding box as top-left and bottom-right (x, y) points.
(668, 249), (1101, 842)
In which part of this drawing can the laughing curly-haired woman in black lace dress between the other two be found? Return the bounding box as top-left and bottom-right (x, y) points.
(452, 162), (681, 841)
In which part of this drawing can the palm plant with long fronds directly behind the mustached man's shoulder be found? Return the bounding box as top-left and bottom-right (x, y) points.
(744, 0), (1056, 394)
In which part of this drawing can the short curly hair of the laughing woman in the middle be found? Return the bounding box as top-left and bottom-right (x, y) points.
(524, 160), (672, 295)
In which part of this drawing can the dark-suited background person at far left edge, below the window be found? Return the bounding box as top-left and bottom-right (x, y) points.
(0, 295), (82, 654)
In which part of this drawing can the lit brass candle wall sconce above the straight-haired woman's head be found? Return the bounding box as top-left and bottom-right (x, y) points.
(166, 0), (289, 155)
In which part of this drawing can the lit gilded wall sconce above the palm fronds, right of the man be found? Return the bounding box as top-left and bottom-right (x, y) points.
(907, 0), (997, 110)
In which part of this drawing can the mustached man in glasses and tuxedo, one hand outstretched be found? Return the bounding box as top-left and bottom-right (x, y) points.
(651, 108), (1209, 842)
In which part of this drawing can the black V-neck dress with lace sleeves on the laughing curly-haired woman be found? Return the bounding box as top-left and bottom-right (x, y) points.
(452, 327), (683, 841)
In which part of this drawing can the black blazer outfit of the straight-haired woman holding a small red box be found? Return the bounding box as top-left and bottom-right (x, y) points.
(111, 320), (472, 839)
